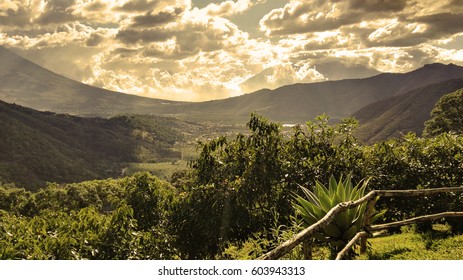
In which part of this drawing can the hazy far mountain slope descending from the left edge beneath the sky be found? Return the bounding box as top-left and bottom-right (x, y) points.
(0, 46), (185, 116)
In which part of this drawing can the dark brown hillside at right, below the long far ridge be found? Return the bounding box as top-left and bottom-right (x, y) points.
(353, 79), (463, 143)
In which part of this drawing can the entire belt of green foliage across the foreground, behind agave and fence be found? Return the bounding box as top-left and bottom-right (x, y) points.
(0, 112), (463, 259)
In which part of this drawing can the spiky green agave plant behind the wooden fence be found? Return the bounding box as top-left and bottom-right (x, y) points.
(293, 175), (385, 255)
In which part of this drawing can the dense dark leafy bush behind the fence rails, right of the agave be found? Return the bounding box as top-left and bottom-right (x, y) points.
(364, 133), (463, 230)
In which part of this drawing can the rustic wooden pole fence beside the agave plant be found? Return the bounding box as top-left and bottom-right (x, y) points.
(259, 187), (463, 260)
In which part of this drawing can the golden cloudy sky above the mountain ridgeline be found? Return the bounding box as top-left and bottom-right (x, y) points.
(0, 0), (463, 101)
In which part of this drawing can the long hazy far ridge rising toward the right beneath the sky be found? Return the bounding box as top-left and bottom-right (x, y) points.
(179, 64), (463, 123)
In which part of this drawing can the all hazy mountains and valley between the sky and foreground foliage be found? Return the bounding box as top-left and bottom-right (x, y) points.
(0, 44), (463, 186)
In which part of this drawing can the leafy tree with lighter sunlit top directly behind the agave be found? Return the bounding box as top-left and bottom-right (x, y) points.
(285, 115), (366, 191)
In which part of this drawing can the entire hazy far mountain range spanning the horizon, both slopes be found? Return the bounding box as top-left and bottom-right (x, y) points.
(0, 47), (463, 123)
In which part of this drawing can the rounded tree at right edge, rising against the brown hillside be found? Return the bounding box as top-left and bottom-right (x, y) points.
(423, 89), (463, 136)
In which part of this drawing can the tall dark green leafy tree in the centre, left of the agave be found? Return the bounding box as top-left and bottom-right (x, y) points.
(173, 114), (290, 258)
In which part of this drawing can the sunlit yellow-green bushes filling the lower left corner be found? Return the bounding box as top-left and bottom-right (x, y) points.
(0, 173), (177, 259)
